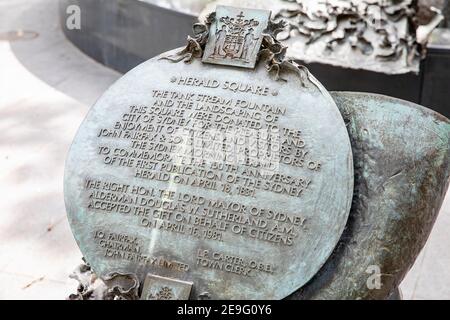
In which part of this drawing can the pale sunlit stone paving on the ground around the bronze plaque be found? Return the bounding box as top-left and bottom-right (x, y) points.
(0, 0), (450, 299)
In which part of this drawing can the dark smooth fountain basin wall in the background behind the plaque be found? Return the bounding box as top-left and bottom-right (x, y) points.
(59, 0), (450, 117)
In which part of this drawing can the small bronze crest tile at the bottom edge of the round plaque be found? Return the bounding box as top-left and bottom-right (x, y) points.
(141, 274), (192, 300)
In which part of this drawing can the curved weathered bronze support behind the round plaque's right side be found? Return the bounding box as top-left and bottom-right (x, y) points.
(289, 92), (450, 299)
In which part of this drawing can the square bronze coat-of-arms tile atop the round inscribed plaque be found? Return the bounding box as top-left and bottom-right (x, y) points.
(203, 6), (271, 69)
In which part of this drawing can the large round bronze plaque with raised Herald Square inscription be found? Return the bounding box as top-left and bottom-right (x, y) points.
(65, 48), (353, 299)
